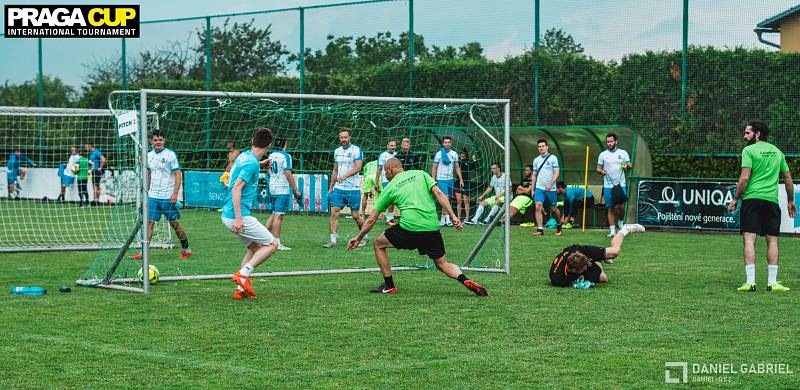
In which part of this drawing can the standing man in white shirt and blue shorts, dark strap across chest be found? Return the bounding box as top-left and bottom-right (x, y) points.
(531, 139), (561, 236)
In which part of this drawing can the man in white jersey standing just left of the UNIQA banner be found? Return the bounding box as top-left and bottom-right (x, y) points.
(597, 133), (633, 237)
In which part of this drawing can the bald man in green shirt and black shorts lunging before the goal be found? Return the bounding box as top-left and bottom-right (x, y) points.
(347, 157), (489, 296)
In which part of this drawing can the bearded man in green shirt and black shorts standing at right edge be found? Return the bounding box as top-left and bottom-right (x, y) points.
(728, 121), (797, 291)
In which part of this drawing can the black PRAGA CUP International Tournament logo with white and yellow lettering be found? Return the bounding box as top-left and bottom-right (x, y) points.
(5, 4), (140, 38)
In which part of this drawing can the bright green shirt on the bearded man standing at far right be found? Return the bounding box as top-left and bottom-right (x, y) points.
(742, 141), (789, 203)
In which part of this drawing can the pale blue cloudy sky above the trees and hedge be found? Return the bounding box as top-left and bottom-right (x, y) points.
(0, 0), (798, 87)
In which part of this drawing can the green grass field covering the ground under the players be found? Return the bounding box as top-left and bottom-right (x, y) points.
(0, 207), (800, 389)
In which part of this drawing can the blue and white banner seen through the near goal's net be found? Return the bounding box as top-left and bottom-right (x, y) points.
(183, 171), (328, 213)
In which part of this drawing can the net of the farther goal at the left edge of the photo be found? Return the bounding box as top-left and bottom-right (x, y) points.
(0, 106), (171, 252)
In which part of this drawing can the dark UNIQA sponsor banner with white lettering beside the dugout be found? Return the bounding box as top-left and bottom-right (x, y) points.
(637, 180), (739, 230)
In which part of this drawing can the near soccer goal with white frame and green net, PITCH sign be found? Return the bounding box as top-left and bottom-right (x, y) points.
(78, 89), (511, 293)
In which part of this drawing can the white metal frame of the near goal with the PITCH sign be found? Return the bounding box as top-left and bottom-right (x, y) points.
(77, 89), (513, 293)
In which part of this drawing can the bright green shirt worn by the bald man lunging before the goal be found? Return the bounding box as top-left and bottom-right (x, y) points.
(375, 171), (439, 232)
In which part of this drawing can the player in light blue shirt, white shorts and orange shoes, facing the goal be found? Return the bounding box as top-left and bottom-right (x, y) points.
(222, 128), (278, 300)
